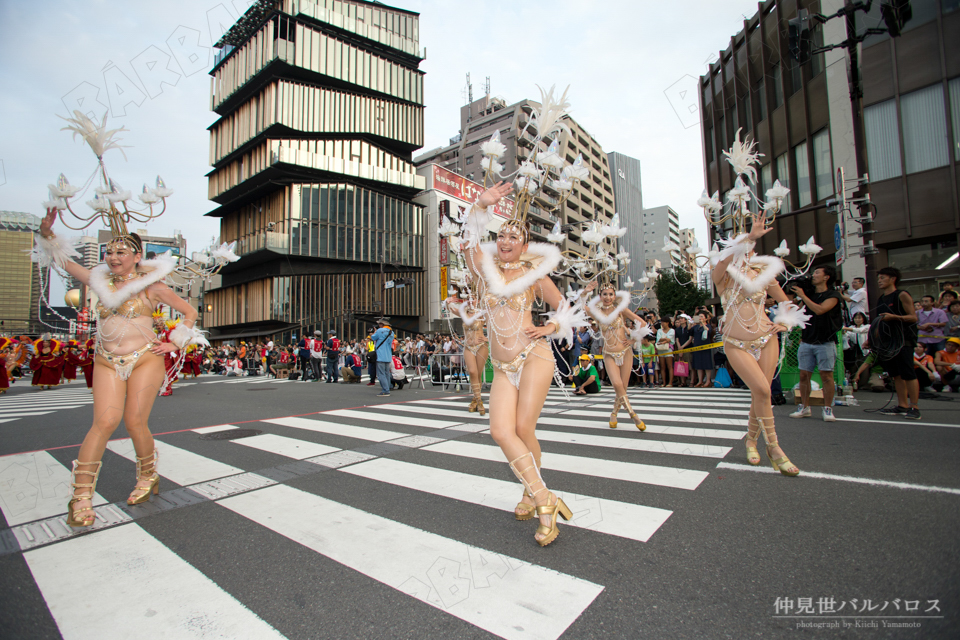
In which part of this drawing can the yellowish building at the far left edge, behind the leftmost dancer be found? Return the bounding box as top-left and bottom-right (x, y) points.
(0, 211), (46, 336)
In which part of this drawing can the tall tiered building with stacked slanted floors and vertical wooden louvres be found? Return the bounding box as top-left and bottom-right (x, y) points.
(204, 0), (425, 340)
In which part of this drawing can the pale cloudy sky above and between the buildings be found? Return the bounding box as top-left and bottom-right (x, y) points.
(0, 0), (757, 258)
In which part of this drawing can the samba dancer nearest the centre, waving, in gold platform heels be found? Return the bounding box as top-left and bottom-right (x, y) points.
(465, 182), (586, 546)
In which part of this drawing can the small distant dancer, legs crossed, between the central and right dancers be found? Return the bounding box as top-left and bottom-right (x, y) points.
(586, 281), (652, 431)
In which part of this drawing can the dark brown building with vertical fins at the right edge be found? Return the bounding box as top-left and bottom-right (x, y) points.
(700, 0), (960, 299)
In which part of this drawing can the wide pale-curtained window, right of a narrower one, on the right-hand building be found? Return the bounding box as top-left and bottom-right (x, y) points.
(900, 84), (949, 178)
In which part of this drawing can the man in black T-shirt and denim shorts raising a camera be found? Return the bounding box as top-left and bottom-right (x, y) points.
(790, 265), (844, 422)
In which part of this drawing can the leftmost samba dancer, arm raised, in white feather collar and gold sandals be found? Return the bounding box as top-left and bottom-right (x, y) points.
(36, 209), (206, 527)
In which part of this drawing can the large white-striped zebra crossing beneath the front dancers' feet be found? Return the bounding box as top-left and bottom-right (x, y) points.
(0, 379), (749, 640)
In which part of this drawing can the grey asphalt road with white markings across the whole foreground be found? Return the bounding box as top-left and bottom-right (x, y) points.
(0, 376), (960, 639)
